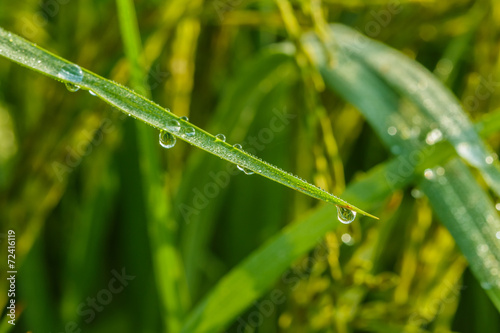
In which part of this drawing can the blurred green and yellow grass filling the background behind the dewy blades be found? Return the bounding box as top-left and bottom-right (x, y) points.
(0, 0), (500, 333)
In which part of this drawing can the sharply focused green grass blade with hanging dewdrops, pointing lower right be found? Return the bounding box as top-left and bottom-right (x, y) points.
(0, 28), (376, 218)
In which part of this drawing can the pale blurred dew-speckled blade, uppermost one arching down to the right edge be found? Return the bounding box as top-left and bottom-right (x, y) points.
(332, 25), (500, 196)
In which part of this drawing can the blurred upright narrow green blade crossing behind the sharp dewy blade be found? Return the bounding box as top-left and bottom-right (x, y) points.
(117, 0), (189, 332)
